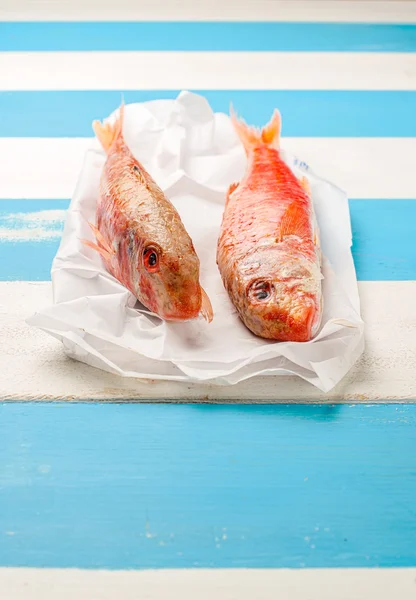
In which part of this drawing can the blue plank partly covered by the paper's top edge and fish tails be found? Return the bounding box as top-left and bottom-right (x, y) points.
(0, 90), (416, 137)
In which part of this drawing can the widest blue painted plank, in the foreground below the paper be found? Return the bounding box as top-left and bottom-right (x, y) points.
(0, 404), (416, 569)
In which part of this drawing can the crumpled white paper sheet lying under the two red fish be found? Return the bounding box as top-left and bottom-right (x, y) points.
(28, 92), (364, 392)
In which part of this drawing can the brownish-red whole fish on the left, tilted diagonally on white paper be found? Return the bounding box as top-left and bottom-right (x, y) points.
(83, 101), (213, 322)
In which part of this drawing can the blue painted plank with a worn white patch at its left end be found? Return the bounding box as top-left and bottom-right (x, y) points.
(0, 200), (416, 281)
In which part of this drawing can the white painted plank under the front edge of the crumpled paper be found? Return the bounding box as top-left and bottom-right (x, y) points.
(0, 281), (416, 402)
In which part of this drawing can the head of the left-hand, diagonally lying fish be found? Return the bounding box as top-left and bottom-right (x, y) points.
(138, 235), (212, 321)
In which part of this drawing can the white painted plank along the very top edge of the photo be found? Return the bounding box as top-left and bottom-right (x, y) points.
(0, 0), (416, 23)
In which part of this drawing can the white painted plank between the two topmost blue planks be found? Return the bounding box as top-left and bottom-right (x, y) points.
(0, 52), (416, 91)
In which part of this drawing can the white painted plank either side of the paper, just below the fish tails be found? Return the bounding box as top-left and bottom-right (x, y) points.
(0, 138), (416, 199)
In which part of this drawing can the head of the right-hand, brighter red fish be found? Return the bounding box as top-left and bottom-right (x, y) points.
(240, 253), (322, 342)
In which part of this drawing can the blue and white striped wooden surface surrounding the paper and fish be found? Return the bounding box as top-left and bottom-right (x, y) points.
(0, 0), (416, 600)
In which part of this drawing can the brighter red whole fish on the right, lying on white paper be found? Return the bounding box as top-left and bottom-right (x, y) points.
(217, 107), (323, 342)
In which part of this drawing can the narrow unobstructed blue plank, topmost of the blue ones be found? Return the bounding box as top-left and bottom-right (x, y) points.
(0, 22), (416, 52)
